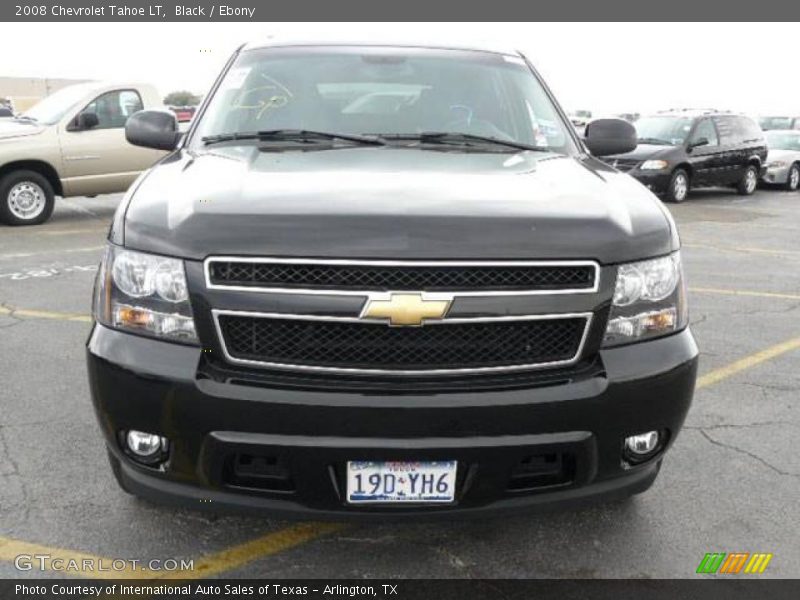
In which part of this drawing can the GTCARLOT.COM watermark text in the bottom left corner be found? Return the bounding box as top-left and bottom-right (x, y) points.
(14, 554), (194, 574)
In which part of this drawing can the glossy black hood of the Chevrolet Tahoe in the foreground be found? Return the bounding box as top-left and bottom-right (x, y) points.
(124, 146), (677, 263)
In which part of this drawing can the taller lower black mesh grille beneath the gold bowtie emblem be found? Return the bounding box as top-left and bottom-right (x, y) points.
(217, 314), (587, 374)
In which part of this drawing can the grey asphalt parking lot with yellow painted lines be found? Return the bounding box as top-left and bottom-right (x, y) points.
(0, 190), (800, 578)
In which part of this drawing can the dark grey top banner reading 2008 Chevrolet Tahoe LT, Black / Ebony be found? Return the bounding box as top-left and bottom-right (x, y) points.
(0, 0), (800, 21)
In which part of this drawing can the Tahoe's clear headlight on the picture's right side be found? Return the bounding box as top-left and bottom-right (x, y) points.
(603, 252), (689, 346)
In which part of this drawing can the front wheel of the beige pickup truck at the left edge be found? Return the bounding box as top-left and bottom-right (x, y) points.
(0, 170), (55, 225)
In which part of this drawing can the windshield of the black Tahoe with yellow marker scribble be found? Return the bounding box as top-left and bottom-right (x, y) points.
(194, 47), (577, 154)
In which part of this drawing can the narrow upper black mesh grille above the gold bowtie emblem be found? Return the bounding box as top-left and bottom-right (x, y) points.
(208, 259), (596, 292)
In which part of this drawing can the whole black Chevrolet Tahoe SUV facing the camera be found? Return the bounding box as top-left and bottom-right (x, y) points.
(87, 42), (698, 518)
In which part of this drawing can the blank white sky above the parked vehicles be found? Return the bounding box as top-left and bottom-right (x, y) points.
(0, 23), (800, 115)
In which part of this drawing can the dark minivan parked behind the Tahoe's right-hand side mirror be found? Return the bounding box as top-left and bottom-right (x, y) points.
(606, 110), (767, 202)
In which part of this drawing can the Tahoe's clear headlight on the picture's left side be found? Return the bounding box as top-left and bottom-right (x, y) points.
(93, 246), (197, 344)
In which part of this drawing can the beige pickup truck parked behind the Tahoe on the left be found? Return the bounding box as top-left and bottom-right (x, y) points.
(0, 82), (164, 225)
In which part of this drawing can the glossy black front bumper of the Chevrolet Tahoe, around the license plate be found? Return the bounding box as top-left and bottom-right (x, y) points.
(87, 325), (697, 519)
